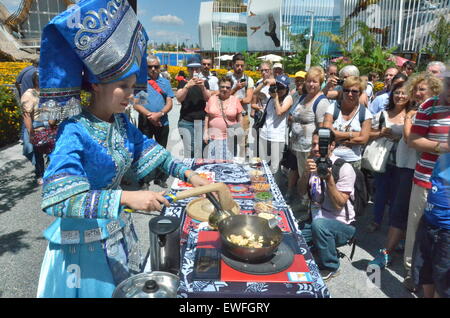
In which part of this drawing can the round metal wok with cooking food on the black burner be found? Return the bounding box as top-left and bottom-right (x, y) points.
(218, 214), (283, 263)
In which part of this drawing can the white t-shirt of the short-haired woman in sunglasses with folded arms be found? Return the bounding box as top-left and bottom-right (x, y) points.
(326, 102), (373, 162)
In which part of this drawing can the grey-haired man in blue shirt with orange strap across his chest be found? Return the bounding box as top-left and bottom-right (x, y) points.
(134, 55), (175, 188)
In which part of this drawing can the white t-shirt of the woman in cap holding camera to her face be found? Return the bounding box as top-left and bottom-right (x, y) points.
(259, 95), (292, 142)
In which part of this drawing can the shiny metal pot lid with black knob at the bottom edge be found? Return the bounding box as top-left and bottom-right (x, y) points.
(112, 272), (180, 298)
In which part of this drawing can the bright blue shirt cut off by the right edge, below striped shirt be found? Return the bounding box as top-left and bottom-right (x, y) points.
(424, 153), (450, 230)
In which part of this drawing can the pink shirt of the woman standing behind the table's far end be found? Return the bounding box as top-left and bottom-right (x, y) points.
(205, 95), (244, 140)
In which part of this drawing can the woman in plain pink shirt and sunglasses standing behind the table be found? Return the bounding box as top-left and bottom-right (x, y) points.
(203, 78), (244, 160)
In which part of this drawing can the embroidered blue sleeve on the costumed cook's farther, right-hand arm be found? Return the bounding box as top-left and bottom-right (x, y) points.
(129, 120), (188, 181)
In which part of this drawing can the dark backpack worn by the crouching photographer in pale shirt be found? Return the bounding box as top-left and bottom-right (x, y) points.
(331, 158), (369, 220)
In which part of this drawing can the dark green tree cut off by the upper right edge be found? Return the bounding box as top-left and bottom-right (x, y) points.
(423, 15), (450, 62)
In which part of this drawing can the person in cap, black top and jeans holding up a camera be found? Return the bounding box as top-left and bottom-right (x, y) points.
(175, 56), (211, 158)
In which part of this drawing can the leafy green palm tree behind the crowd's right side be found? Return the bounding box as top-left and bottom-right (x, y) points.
(323, 21), (397, 75)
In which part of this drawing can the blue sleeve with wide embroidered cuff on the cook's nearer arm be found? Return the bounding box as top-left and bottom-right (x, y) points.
(41, 122), (122, 219)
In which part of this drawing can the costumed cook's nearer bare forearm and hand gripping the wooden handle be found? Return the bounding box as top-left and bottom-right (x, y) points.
(120, 191), (170, 211)
